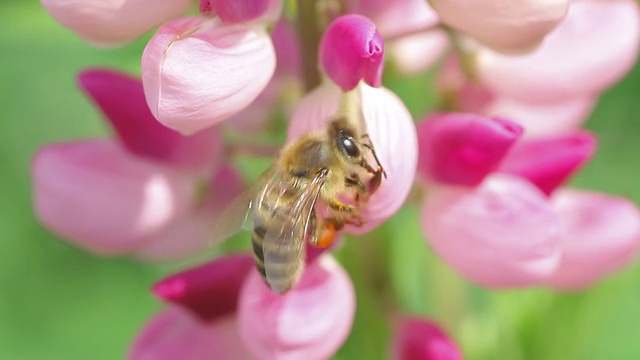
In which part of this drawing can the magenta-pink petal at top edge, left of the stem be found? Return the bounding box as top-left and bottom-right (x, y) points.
(200, 0), (282, 24)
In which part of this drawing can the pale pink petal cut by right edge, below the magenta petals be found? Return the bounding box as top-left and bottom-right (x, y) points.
(547, 190), (640, 290)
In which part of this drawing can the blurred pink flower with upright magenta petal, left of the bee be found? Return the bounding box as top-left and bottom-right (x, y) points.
(32, 70), (241, 260)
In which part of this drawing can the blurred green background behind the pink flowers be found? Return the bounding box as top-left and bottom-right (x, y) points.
(0, 0), (640, 360)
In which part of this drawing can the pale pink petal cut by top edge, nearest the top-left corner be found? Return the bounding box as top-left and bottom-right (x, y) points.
(41, 0), (191, 46)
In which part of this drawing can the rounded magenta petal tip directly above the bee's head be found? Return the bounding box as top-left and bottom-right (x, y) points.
(320, 14), (384, 91)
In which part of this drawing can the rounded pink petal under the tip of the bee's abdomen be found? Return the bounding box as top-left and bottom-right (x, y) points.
(238, 255), (355, 359)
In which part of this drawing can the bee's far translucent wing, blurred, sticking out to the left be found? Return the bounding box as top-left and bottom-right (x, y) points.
(211, 167), (275, 243)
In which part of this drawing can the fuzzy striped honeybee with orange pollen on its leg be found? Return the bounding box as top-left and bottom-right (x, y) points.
(215, 116), (386, 294)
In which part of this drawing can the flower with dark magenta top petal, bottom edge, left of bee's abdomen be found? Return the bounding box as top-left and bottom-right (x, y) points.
(129, 255), (255, 360)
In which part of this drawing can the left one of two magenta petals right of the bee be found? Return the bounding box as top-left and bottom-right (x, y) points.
(418, 113), (523, 186)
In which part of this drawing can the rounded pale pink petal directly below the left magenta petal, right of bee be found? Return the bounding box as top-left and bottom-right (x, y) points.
(422, 174), (561, 288)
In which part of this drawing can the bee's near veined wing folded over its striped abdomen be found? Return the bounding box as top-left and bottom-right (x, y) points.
(263, 171), (327, 291)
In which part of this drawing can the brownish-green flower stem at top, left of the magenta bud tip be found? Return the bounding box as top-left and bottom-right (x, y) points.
(296, 0), (321, 92)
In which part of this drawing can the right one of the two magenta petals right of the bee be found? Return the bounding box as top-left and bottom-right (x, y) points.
(500, 131), (596, 195)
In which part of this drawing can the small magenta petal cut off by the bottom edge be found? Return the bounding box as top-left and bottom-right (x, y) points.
(393, 318), (462, 360)
